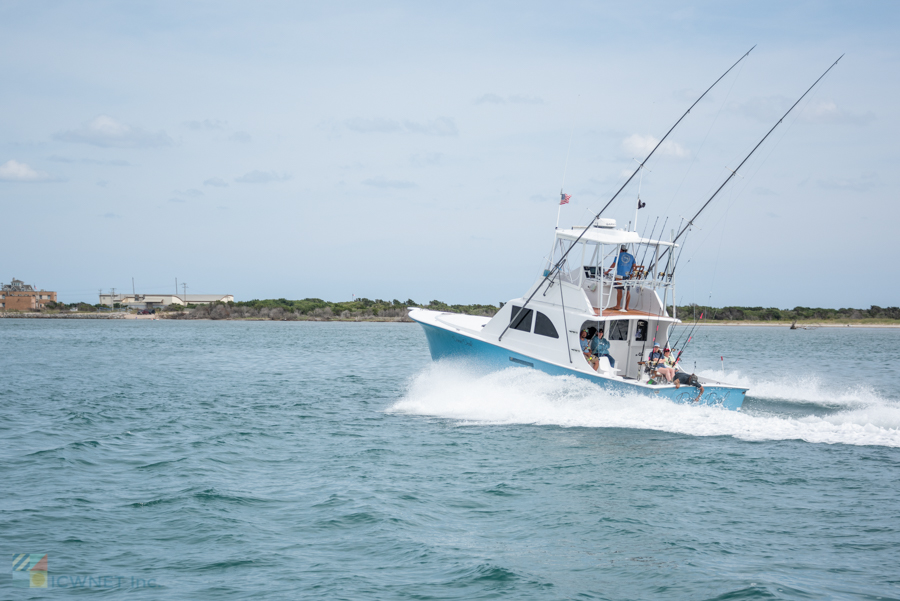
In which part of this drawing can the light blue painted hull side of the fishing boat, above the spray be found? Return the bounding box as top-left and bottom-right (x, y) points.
(419, 322), (747, 410)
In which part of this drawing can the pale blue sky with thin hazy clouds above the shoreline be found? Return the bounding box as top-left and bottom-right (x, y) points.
(0, 0), (900, 308)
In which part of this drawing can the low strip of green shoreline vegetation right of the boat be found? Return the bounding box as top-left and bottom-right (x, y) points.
(678, 305), (900, 323)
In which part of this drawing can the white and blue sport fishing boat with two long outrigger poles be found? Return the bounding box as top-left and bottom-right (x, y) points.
(409, 48), (843, 410)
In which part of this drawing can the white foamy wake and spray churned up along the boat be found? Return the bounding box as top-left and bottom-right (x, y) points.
(388, 362), (900, 447)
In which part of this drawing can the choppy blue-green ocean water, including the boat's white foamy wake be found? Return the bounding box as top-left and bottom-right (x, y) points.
(0, 319), (900, 600)
